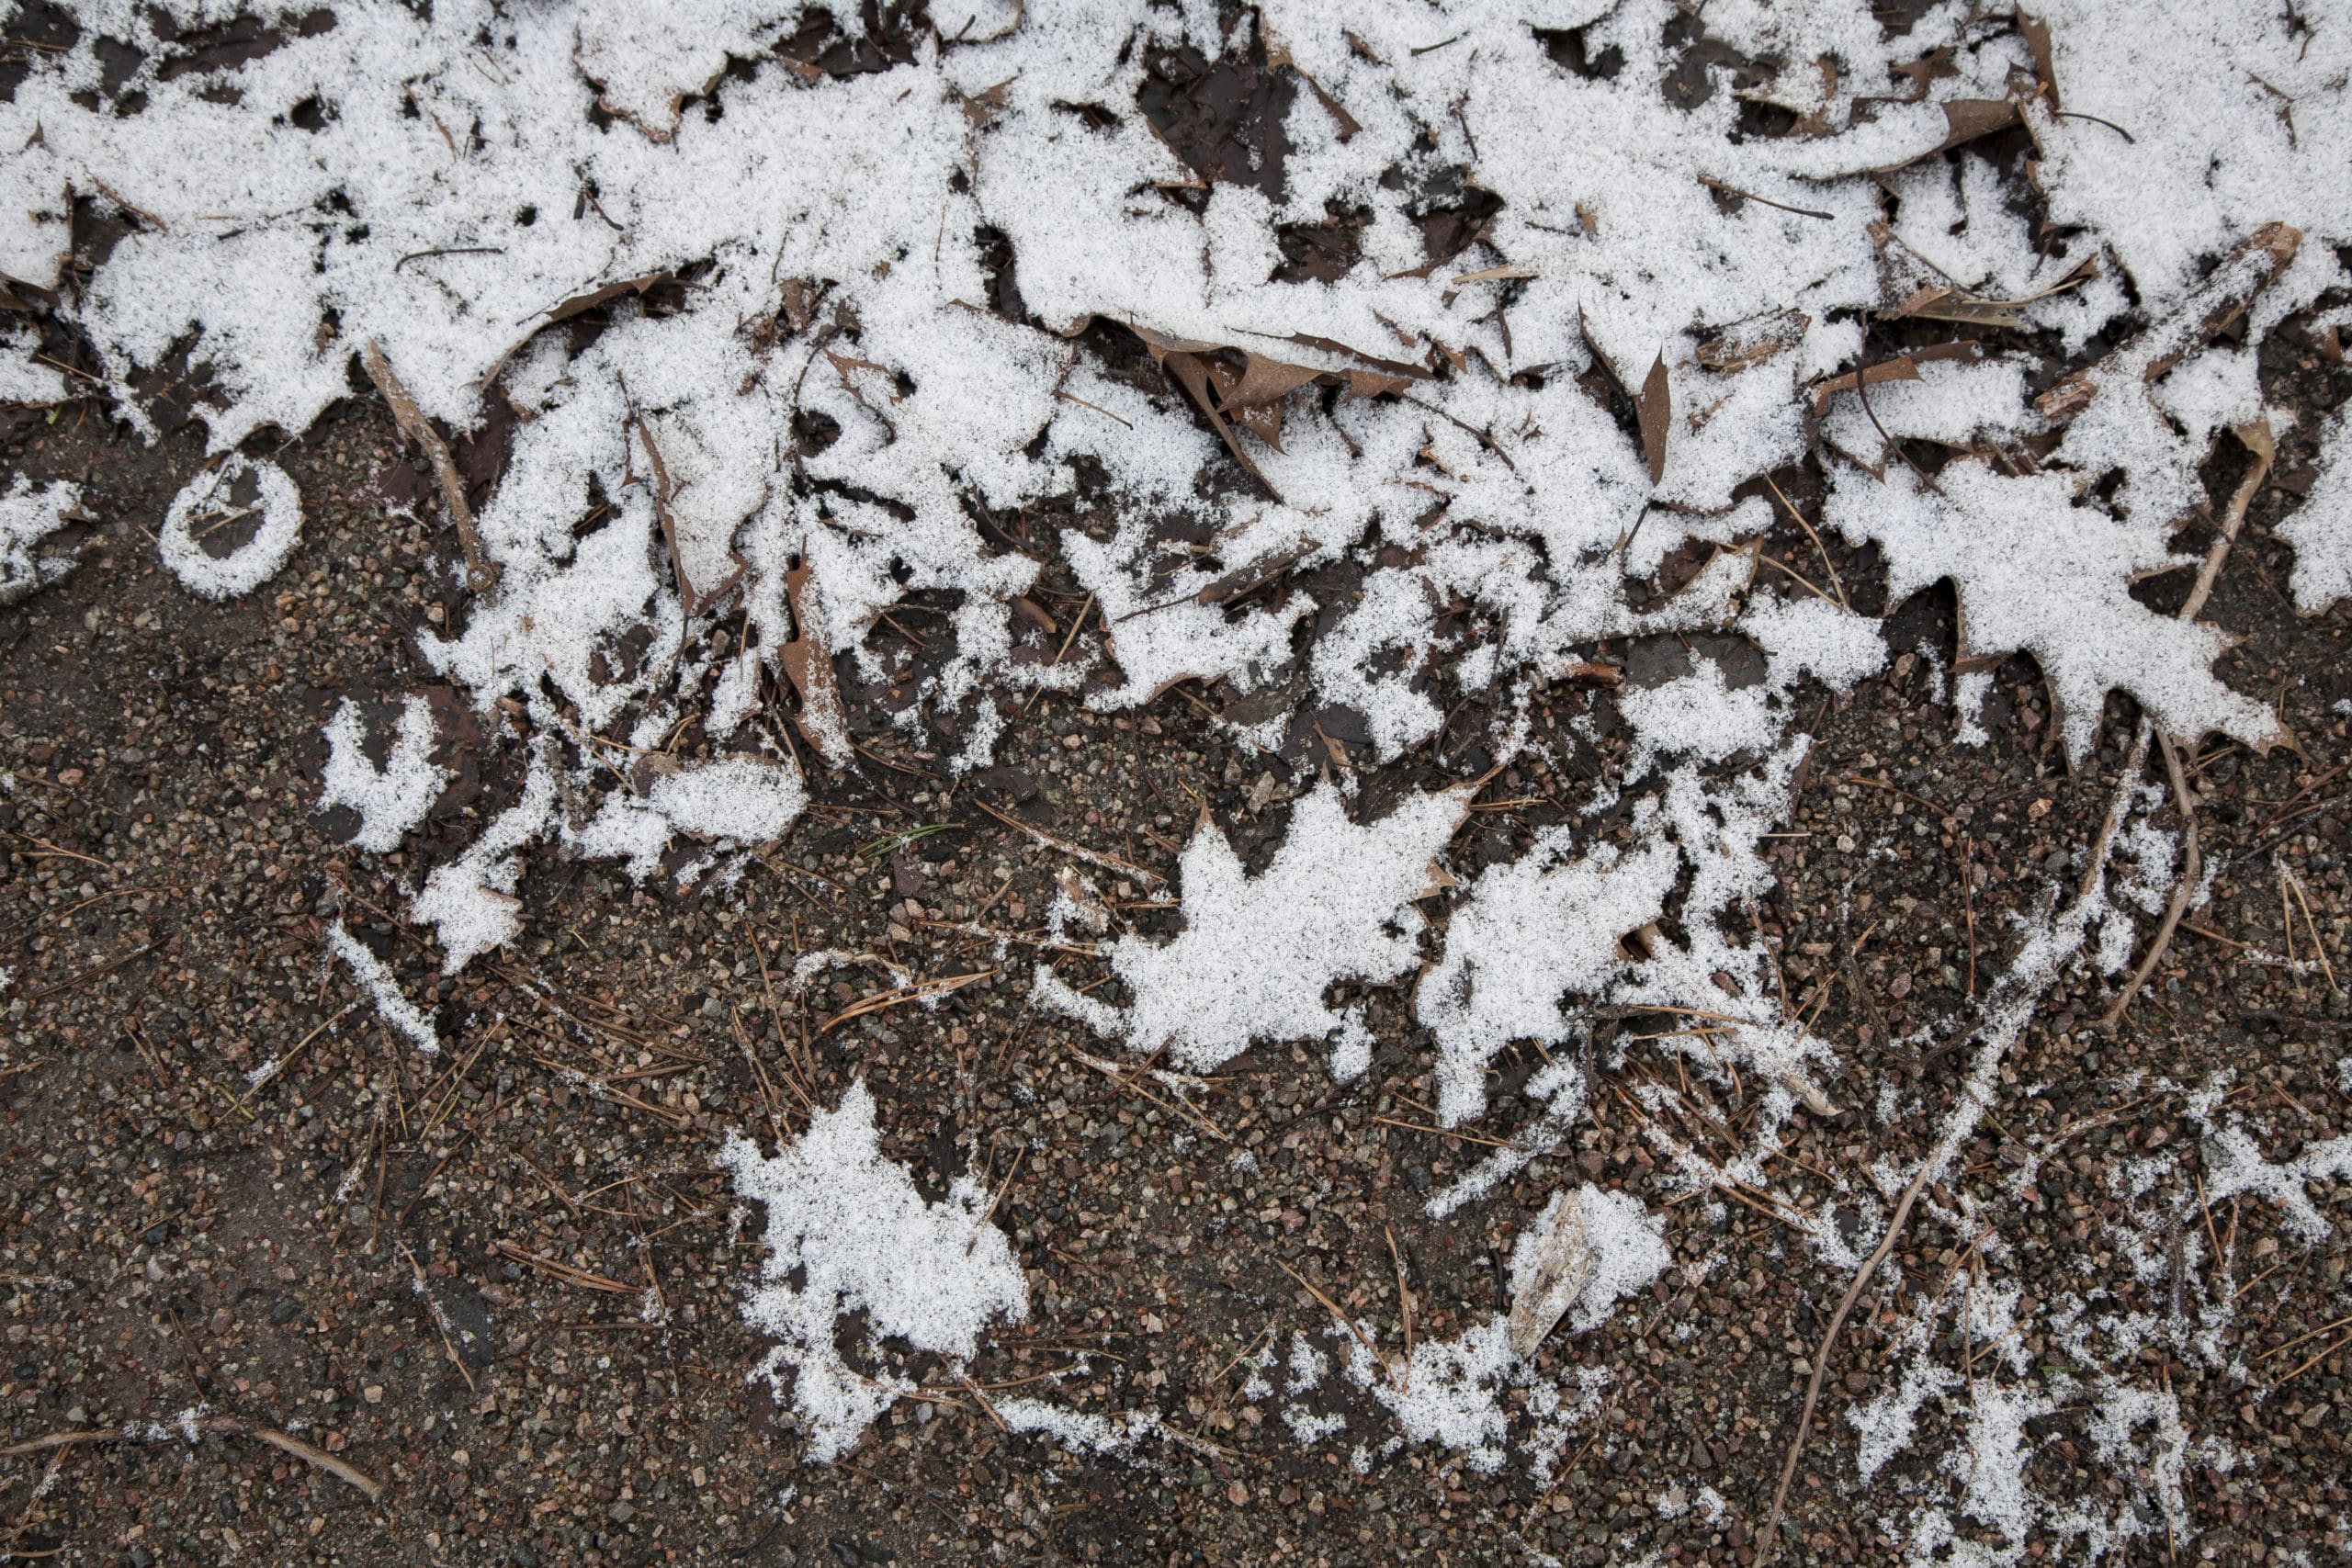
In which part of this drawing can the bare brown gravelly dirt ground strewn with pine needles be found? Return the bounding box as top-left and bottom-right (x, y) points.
(0, 300), (2352, 1565)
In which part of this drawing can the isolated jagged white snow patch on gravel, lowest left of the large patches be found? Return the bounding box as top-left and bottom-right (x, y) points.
(718, 1081), (1025, 1462)
